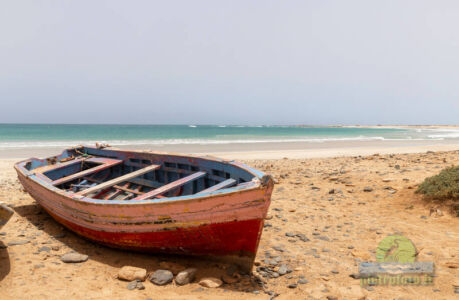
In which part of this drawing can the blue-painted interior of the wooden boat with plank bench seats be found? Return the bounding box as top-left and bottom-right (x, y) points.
(23, 146), (263, 200)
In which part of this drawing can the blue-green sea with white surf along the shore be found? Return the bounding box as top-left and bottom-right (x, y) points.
(0, 124), (459, 149)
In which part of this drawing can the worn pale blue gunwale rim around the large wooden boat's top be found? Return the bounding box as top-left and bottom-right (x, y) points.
(14, 146), (273, 206)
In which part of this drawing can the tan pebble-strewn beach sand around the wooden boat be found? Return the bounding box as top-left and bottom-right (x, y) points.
(0, 144), (459, 300)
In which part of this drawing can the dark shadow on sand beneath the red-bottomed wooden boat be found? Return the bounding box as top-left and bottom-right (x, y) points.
(14, 203), (263, 292)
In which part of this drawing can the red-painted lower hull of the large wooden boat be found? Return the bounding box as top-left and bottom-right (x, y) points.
(48, 207), (263, 258)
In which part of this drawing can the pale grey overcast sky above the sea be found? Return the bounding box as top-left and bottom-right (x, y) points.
(0, 0), (459, 124)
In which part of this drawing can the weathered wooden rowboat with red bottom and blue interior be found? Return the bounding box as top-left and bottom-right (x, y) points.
(15, 146), (273, 270)
